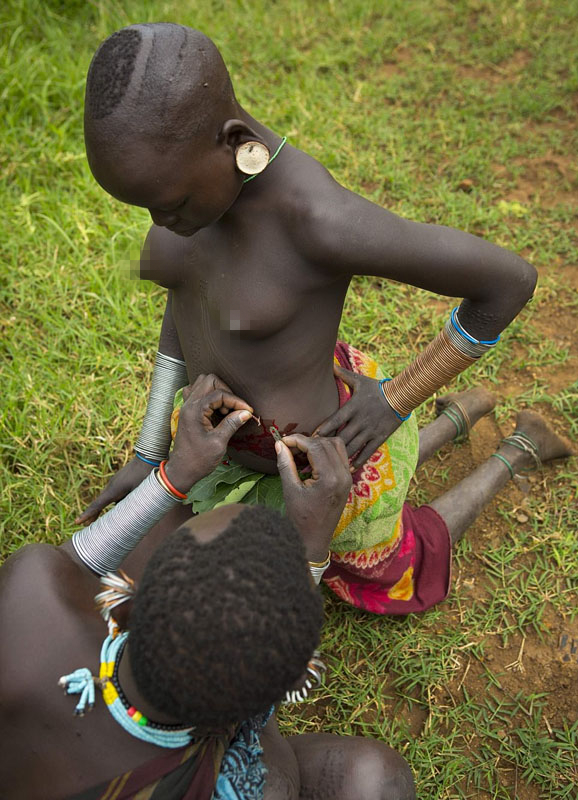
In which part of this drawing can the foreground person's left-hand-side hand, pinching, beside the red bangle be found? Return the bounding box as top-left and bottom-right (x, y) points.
(165, 375), (253, 492)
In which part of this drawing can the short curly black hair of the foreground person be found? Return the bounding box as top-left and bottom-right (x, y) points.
(129, 506), (323, 729)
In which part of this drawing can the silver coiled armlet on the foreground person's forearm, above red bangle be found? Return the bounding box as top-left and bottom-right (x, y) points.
(72, 470), (180, 575)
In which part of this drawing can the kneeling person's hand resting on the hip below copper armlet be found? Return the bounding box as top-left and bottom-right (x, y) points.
(313, 364), (401, 471)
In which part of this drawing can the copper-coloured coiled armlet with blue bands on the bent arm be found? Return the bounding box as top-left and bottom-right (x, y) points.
(380, 308), (500, 420)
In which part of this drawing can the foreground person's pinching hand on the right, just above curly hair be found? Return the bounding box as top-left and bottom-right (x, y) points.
(275, 433), (351, 561)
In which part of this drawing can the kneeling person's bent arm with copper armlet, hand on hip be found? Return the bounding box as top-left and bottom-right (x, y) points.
(301, 178), (536, 467)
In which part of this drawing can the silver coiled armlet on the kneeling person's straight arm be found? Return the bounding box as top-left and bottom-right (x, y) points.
(135, 352), (188, 462)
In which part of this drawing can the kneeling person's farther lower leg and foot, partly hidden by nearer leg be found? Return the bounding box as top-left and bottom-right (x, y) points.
(417, 387), (496, 466)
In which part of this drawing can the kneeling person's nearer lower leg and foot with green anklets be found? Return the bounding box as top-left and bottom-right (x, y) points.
(430, 411), (572, 542)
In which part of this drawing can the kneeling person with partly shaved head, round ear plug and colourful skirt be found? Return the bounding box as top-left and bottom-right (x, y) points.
(79, 23), (539, 613)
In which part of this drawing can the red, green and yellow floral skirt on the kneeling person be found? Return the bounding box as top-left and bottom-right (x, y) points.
(173, 342), (451, 615)
